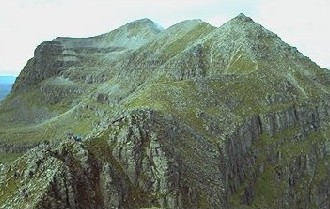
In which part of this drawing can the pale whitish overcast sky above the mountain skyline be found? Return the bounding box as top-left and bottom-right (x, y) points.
(0, 0), (330, 76)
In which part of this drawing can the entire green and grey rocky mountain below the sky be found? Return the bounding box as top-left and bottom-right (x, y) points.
(0, 14), (330, 209)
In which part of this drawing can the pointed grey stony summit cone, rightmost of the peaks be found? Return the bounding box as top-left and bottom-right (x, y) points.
(204, 13), (305, 72)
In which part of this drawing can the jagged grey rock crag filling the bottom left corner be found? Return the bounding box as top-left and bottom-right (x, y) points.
(1, 142), (103, 208)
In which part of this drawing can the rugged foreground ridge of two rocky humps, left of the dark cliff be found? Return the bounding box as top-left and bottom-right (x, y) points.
(1, 110), (222, 208)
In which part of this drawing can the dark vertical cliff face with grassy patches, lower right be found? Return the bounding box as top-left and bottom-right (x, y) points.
(225, 103), (330, 208)
